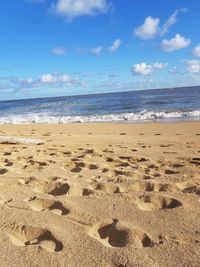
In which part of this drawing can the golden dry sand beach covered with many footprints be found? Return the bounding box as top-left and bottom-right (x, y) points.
(0, 122), (200, 267)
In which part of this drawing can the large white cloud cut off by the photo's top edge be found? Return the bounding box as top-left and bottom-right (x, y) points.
(52, 0), (109, 19)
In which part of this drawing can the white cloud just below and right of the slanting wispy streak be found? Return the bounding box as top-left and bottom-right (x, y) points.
(161, 34), (191, 52)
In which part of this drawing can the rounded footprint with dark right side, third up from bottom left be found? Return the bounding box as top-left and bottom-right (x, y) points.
(34, 180), (70, 196)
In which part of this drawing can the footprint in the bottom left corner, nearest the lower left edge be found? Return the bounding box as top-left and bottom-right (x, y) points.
(7, 225), (63, 252)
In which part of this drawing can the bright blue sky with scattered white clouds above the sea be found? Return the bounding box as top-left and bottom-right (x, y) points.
(0, 0), (200, 100)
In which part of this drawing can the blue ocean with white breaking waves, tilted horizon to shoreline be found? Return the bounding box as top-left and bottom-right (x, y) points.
(0, 86), (200, 124)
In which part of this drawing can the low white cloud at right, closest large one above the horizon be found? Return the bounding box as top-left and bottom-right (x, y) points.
(132, 62), (166, 75)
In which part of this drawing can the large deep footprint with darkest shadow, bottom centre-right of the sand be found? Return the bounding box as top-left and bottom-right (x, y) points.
(89, 219), (153, 248)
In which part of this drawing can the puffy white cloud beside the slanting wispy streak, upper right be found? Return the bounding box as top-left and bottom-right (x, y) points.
(134, 17), (160, 40)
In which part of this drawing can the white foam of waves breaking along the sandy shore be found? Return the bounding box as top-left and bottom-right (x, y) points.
(0, 110), (200, 124)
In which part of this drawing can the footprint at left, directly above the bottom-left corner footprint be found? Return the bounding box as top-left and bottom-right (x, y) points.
(27, 197), (70, 215)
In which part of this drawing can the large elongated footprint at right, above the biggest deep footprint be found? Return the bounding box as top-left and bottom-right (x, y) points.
(135, 194), (182, 211)
